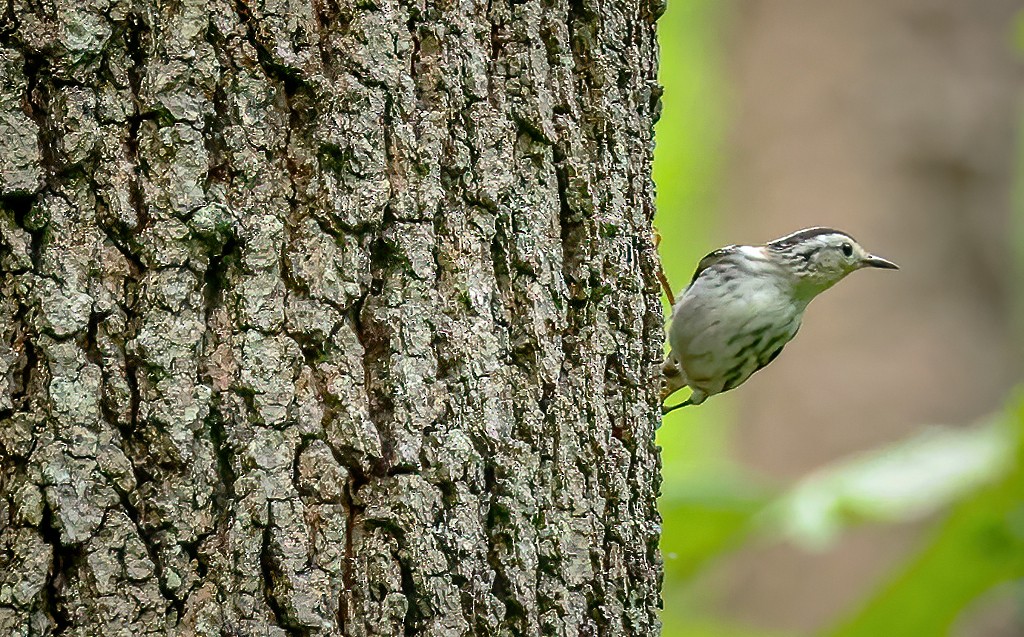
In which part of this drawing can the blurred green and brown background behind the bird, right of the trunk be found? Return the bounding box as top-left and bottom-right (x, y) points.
(654, 0), (1024, 637)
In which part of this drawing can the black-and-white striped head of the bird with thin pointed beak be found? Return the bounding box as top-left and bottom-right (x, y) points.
(765, 227), (899, 300)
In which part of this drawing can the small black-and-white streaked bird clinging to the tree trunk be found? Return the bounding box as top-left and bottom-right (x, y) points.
(662, 227), (899, 414)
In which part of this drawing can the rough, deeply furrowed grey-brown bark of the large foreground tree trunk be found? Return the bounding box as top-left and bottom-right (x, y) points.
(0, 0), (662, 637)
